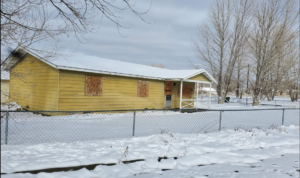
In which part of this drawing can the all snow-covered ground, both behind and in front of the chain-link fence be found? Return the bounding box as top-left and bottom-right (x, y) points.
(1, 101), (300, 178)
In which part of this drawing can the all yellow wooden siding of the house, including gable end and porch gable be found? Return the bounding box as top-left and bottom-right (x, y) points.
(10, 54), (213, 111)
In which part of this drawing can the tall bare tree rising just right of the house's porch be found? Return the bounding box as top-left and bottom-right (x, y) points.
(194, 0), (252, 104)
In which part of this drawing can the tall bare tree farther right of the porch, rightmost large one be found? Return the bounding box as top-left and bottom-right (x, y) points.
(248, 0), (299, 106)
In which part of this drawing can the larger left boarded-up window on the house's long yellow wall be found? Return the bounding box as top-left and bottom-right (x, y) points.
(84, 75), (102, 96)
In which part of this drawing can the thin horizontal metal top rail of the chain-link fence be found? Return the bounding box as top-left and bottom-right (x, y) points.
(1, 108), (300, 113)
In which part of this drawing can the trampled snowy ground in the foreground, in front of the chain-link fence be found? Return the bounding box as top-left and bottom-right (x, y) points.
(1, 126), (300, 178)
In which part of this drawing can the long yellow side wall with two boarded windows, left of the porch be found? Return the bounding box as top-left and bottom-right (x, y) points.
(58, 70), (165, 111)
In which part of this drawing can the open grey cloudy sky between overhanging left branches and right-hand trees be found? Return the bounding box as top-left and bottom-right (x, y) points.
(59, 0), (209, 69)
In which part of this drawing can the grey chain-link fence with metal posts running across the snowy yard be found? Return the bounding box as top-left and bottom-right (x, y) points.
(1, 108), (300, 145)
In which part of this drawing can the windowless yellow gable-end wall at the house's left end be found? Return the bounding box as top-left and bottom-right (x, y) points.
(9, 54), (59, 110)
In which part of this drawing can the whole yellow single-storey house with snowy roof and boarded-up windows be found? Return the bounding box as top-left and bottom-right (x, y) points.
(4, 47), (216, 111)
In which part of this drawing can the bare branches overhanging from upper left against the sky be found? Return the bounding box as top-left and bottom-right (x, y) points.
(1, 0), (151, 57)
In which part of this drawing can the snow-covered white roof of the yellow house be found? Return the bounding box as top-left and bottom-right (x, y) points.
(4, 47), (216, 82)
